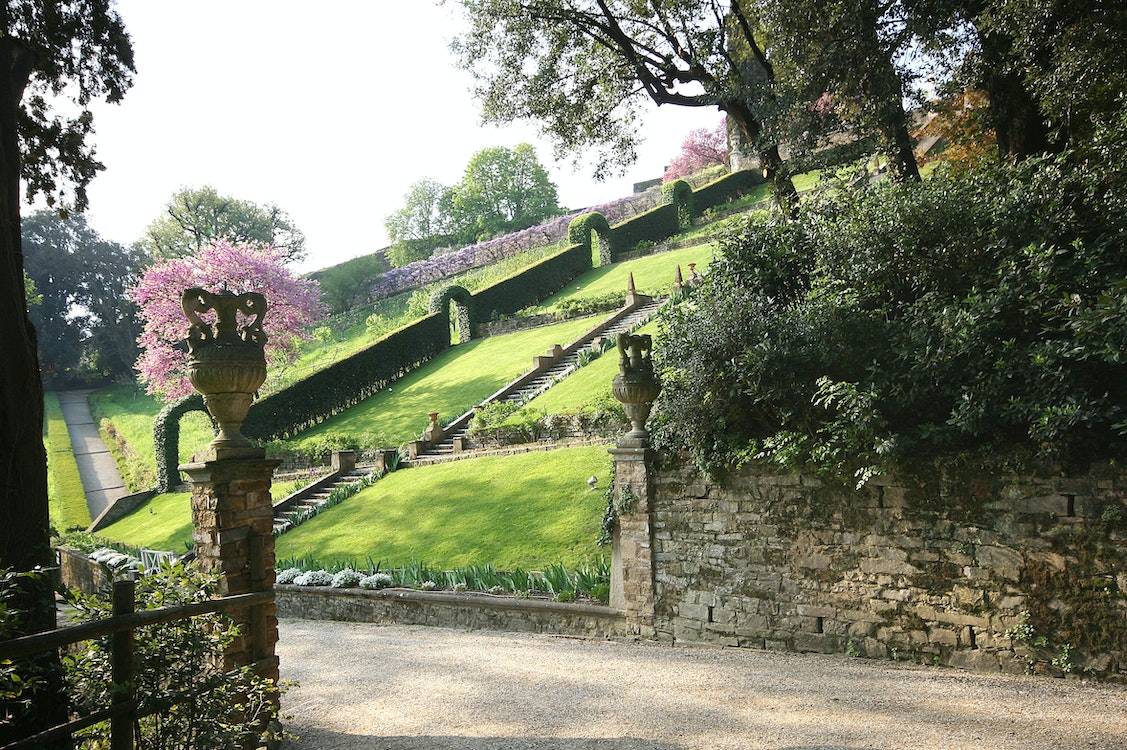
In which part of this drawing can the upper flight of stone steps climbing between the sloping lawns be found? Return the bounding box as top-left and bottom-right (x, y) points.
(411, 297), (665, 464)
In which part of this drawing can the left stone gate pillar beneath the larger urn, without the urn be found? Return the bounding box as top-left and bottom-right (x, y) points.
(179, 449), (278, 680)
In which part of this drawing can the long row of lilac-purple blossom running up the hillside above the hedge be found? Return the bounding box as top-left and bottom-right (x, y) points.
(371, 188), (662, 300)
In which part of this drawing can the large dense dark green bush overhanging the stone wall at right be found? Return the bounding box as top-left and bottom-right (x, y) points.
(654, 118), (1127, 482)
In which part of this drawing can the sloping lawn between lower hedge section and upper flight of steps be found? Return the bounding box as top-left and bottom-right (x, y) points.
(295, 317), (598, 447)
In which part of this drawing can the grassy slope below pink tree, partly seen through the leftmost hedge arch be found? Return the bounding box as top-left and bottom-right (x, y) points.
(90, 385), (212, 492)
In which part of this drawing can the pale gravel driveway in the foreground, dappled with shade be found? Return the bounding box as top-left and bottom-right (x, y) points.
(278, 620), (1127, 750)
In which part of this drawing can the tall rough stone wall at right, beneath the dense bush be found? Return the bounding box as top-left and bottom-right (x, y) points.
(635, 461), (1127, 680)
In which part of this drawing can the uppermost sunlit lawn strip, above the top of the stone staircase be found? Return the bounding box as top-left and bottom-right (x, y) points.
(535, 244), (715, 312)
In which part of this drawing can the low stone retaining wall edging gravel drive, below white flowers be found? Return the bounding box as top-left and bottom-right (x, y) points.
(274, 585), (623, 638)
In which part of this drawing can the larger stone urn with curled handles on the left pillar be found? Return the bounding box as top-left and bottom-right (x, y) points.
(180, 288), (266, 458)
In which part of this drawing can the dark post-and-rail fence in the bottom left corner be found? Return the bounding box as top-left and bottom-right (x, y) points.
(0, 580), (274, 750)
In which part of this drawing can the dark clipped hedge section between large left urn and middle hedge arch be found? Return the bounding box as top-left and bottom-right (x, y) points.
(242, 312), (450, 440)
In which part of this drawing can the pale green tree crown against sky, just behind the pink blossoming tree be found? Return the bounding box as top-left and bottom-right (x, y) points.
(140, 185), (305, 262)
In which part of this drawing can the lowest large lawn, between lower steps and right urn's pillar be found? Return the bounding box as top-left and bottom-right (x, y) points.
(277, 445), (611, 561)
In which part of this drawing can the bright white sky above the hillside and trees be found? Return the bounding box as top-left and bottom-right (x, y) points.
(81, 0), (720, 271)
